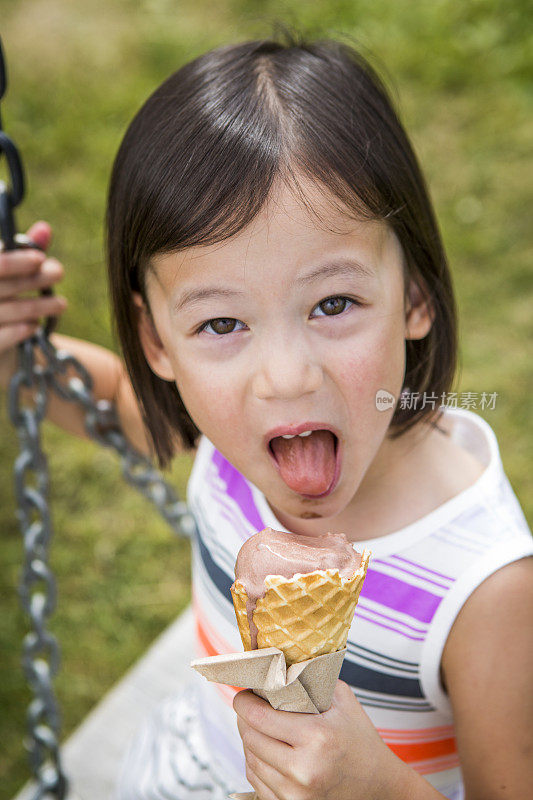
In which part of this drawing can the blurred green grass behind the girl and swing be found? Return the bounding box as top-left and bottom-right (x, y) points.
(0, 0), (533, 798)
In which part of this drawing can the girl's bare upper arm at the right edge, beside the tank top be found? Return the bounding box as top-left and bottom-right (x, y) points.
(442, 558), (533, 800)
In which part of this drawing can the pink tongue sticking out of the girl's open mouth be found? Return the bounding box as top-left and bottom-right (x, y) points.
(271, 431), (335, 494)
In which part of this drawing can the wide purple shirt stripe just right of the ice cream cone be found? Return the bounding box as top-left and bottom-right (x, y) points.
(361, 567), (442, 622)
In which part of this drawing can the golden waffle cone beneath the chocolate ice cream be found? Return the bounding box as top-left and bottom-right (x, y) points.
(231, 550), (370, 666)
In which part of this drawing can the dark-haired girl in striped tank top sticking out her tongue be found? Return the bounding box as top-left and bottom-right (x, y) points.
(0, 32), (533, 800)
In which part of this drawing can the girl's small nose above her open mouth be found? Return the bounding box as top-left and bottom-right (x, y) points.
(252, 340), (323, 400)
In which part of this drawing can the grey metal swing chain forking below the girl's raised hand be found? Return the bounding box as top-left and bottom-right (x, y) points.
(0, 40), (195, 800)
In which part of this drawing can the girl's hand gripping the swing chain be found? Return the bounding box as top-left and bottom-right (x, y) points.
(0, 222), (67, 384)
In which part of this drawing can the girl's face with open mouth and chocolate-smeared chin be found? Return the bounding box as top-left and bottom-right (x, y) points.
(136, 178), (431, 534)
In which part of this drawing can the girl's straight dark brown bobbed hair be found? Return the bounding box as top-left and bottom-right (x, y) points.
(107, 30), (457, 466)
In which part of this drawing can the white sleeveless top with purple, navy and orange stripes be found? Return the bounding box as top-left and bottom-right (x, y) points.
(187, 409), (533, 800)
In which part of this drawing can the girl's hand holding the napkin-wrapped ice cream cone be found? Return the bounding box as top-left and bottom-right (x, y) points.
(233, 681), (408, 800)
